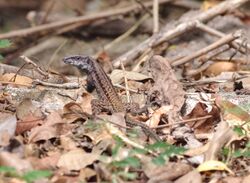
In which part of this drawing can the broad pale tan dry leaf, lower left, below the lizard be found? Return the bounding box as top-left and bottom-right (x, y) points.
(57, 149), (99, 170)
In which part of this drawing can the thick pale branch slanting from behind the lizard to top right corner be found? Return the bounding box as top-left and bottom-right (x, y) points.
(113, 0), (249, 68)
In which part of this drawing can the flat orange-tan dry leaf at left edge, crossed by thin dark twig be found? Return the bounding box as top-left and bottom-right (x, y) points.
(0, 73), (33, 86)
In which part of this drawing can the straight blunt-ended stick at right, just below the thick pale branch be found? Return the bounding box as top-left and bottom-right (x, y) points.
(171, 31), (242, 66)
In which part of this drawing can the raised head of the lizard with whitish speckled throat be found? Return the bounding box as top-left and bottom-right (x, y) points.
(63, 55), (93, 72)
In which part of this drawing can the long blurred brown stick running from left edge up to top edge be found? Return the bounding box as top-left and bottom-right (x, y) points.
(0, 0), (171, 39)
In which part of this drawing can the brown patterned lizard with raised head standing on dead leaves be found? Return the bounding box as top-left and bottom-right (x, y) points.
(63, 55), (161, 141)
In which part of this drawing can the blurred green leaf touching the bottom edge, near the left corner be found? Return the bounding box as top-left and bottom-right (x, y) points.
(22, 170), (52, 183)
